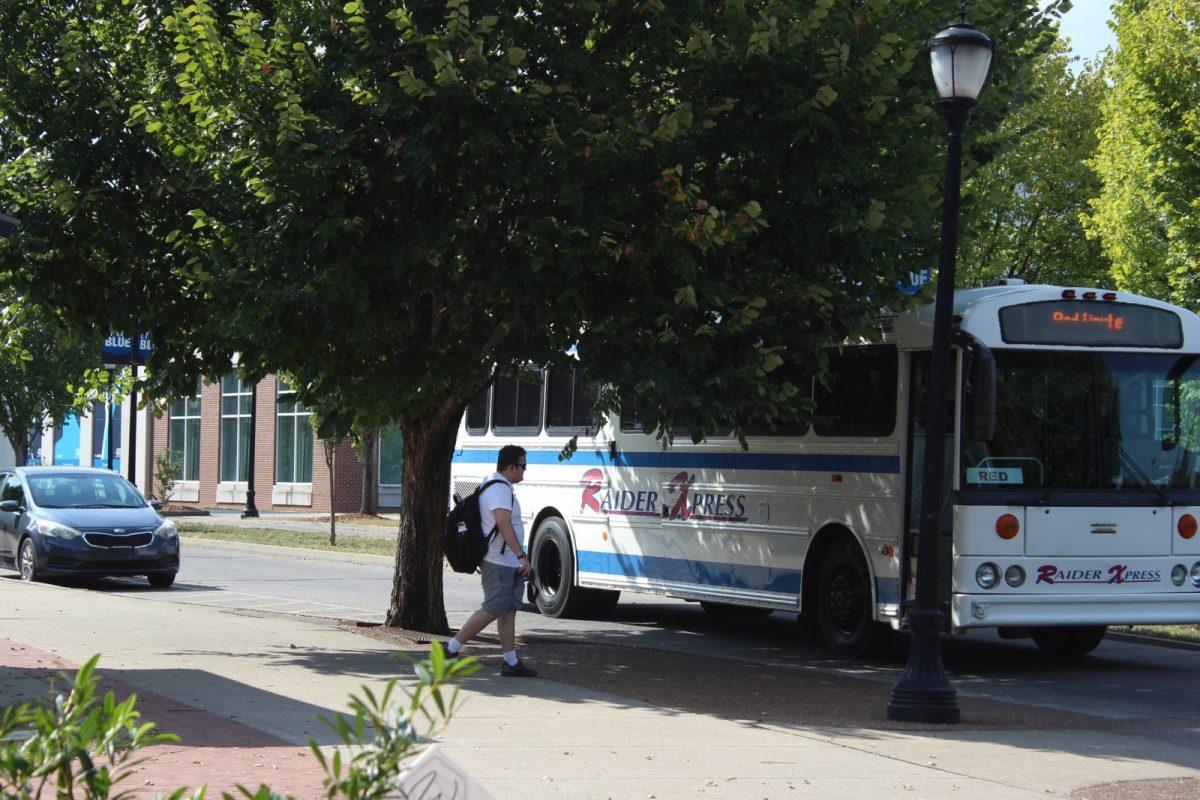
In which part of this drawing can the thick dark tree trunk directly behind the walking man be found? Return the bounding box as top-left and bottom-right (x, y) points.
(386, 414), (458, 633)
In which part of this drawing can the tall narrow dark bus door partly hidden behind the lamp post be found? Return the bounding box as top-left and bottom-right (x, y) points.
(900, 350), (959, 619)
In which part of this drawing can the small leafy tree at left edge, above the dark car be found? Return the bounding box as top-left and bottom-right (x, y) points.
(0, 309), (103, 464)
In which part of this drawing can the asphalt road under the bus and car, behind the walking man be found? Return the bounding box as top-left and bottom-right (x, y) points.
(16, 545), (1200, 734)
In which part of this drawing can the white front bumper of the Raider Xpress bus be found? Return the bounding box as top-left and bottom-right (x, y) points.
(950, 591), (1200, 630)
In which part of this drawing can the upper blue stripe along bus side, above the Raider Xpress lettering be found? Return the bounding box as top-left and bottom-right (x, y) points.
(454, 449), (900, 475)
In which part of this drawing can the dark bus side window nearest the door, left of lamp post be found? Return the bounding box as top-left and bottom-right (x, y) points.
(814, 344), (898, 437)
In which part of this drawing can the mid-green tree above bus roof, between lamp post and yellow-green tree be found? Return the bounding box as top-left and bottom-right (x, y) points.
(958, 46), (1110, 287)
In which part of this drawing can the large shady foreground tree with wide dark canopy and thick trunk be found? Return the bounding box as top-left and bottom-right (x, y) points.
(0, 0), (1061, 630)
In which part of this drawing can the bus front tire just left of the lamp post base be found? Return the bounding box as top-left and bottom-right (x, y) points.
(817, 537), (887, 658)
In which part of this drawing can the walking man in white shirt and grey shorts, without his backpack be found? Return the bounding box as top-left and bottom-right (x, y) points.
(446, 445), (538, 678)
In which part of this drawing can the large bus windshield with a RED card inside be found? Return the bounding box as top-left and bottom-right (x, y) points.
(960, 350), (1200, 493)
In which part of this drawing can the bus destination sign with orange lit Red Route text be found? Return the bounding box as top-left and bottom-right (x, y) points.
(1000, 300), (1183, 348)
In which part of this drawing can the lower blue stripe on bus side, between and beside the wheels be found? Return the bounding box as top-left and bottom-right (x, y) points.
(578, 551), (900, 603)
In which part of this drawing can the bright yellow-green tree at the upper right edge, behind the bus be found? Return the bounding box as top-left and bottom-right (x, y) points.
(1087, 0), (1200, 306)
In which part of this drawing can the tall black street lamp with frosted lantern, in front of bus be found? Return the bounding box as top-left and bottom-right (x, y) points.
(888, 13), (994, 722)
